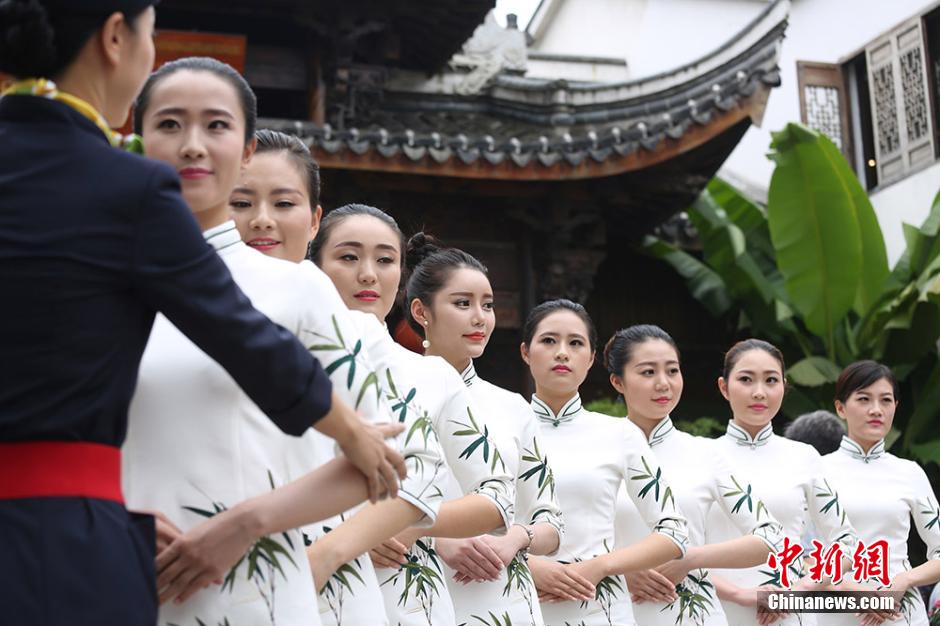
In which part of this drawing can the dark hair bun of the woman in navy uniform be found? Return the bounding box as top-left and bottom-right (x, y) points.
(0, 0), (56, 78)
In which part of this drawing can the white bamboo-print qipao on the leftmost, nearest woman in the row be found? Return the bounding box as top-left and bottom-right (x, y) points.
(122, 222), (332, 626)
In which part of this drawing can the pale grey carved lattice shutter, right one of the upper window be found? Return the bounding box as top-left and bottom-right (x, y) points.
(865, 18), (934, 184)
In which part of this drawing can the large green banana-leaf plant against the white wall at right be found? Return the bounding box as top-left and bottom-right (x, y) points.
(643, 124), (940, 464)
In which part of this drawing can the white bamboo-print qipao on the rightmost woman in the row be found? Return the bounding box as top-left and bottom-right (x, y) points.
(818, 437), (940, 626)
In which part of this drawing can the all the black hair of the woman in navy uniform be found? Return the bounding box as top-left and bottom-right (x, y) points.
(0, 0), (147, 78)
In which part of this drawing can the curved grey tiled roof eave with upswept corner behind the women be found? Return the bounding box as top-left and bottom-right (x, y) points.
(262, 0), (789, 179)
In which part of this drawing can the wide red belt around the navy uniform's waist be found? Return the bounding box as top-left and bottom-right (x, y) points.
(0, 441), (124, 504)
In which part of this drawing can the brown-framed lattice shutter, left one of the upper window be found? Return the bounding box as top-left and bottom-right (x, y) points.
(796, 61), (852, 158)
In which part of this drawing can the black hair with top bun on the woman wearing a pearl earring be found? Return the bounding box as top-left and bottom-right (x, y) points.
(404, 232), (488, 334)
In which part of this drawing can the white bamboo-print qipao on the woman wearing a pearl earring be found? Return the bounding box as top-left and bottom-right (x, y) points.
(445, 361), (564, 626)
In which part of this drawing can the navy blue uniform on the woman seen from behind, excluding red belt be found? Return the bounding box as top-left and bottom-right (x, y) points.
(0, 96), (331, 626)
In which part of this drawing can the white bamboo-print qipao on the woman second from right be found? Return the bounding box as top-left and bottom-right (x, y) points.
(705, 421), (858, 626)
